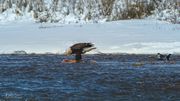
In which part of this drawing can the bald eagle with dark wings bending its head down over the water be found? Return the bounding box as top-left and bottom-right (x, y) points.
(65, 43), (96, 62)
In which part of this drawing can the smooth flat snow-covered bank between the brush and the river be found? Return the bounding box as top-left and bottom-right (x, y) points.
(0, 19), (180, 54)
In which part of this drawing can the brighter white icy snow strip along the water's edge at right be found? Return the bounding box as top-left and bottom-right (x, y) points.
(104, 42), (180, 54)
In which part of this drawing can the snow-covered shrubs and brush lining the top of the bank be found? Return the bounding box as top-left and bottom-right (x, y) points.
(0, 0), (180, 23)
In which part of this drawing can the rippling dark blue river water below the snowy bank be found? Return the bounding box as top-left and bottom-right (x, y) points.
(0, 55), (180, 101)
